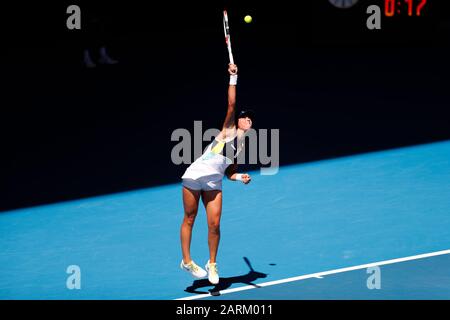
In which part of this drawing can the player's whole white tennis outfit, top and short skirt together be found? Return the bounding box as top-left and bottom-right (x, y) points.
(181, 137), (242, 190)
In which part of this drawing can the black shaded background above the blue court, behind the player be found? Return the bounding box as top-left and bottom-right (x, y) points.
(0, 0), (450, 211)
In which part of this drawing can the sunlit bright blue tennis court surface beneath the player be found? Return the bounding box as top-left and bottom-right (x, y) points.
(0, 141), (450, 299)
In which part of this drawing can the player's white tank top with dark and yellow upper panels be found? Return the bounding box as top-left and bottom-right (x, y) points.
(181, 137), (242, 180)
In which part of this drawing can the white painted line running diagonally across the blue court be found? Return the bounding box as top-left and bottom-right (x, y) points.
(175, 249), (450, 300)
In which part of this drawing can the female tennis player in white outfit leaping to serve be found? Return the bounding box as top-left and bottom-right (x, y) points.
(180, 64), (254, 284)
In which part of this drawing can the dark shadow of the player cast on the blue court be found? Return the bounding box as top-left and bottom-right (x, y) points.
(184, 257), (267, 296)
